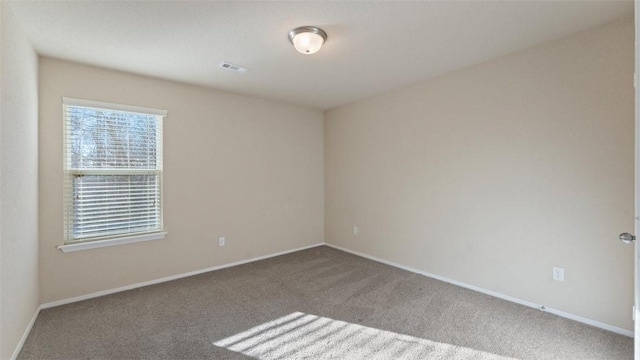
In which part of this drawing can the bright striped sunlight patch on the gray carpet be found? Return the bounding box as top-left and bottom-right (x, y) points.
(213, 312), (512, 360)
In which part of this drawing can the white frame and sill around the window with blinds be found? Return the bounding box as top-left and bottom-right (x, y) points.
(58, 97), (167, 252)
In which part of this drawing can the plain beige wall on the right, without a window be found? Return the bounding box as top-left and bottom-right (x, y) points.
(325, 19), (634, 330)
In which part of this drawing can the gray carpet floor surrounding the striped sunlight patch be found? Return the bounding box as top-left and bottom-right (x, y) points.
(18, 246), (633, 360)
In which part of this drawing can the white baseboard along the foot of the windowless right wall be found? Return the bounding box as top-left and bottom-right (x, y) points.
(325, 243), (634, 338)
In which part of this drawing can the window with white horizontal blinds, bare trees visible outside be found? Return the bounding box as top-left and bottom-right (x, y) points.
(61, 98), (166, 251)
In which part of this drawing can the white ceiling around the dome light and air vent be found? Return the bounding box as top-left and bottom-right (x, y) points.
(5, 0), (633, 110)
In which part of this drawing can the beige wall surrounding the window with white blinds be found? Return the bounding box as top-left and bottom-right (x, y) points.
(39, 58), (324, 303)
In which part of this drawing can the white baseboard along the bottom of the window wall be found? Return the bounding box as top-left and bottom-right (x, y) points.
(40, 243), (325, 309)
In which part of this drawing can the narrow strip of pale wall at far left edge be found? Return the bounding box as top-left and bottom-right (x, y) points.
(0, 2), (39, 359)
